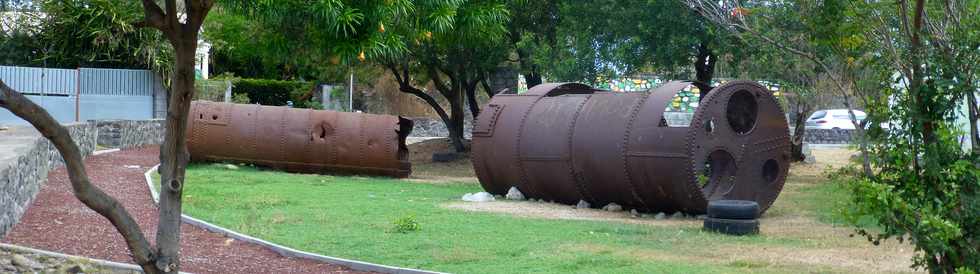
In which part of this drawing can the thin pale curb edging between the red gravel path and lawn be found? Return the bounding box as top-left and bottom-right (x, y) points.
(143, 165), (445, 274)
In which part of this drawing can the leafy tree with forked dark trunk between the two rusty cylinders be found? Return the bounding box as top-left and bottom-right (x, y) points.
(379, 0), (509, 151)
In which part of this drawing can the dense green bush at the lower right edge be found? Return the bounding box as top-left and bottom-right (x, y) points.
(843, 82), (980, 273)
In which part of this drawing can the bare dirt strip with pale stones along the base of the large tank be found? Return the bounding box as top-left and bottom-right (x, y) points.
(442, 201), (701, 228)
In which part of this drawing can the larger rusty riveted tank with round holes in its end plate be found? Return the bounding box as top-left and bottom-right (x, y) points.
(473, 81), (789, 214)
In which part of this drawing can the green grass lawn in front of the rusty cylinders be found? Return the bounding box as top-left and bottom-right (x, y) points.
(157, 155), (916, 273)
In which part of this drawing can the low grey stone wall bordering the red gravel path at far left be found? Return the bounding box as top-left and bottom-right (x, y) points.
(0, 120), (163, 238)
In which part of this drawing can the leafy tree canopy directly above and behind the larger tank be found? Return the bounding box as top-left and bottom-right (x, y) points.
(538, 0), (738, 95)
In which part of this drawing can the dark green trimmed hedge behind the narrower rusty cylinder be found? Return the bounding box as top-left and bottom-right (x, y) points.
(232, 79), (313, 106)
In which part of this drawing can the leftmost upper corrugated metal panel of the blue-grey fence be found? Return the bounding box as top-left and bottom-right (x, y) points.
(0, 66), (78, 95)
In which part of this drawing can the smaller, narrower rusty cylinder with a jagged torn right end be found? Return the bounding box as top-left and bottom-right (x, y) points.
(187, 101), (413, 177)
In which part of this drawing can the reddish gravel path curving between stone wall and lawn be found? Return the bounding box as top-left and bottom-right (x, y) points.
(3, 147), (372, 273)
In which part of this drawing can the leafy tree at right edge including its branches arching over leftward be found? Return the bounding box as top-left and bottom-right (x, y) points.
(688, 0), (980, 273)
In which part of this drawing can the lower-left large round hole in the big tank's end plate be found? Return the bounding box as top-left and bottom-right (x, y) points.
(698, 149), (737, 200)
